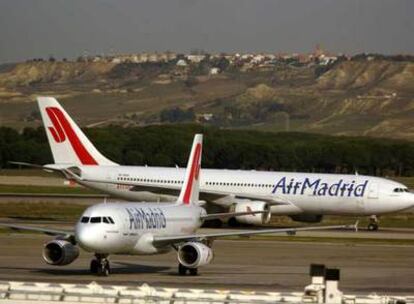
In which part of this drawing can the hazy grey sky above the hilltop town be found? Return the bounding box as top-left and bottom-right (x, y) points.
(0, 0), (414, 62)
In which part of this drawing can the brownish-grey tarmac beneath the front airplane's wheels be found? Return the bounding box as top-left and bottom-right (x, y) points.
(0, 233), (414, 294)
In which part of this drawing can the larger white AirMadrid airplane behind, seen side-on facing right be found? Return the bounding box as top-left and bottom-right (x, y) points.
(14, 97), (414, 230)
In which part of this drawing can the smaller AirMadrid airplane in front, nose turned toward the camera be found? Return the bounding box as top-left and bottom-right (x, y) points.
(0, 134), (357, 276)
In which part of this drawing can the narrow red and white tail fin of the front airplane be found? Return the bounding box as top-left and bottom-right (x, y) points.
(177, 134), (203, 205)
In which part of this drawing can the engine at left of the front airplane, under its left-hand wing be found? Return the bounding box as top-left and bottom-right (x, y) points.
(43, 240), (79, 266)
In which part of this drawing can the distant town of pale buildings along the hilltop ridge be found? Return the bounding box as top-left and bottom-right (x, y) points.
(28, 46), (414, 75)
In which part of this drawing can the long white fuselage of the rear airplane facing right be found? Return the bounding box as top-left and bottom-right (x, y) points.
(80, 166), (414, 215)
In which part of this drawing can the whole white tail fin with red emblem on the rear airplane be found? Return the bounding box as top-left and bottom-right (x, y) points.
(37, 97), (117, 166)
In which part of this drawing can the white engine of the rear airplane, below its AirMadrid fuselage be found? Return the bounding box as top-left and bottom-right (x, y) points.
(234, 201), (271, 225)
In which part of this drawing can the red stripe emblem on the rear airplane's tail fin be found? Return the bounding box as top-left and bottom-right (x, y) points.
(46, 107), (98, 165)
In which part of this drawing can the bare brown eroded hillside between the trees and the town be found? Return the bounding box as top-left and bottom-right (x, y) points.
(0, 59), (414, 140)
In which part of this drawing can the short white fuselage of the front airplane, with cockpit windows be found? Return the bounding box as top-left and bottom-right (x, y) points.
(75, 203), (206, 255)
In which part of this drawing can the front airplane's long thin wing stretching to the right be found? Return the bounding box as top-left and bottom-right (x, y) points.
(153, 222), (358, 247)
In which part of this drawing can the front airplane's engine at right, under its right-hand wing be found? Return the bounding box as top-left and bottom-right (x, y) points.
(178, 242), (213, 268)
